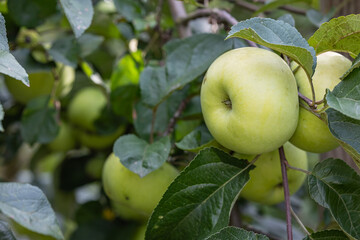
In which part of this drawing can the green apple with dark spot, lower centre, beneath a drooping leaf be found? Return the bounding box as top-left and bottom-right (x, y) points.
(102, 153), (179, 217)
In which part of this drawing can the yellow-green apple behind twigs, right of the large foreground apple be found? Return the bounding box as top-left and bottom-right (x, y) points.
(290, 52), (351, 153)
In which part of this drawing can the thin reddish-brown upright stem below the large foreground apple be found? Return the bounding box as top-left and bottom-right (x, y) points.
(279, 146), (293, 240)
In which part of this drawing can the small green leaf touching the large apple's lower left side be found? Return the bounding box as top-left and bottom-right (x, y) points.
(175, 126), (214, 151)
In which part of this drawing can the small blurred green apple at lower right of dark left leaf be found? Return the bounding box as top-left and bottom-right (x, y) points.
(47, 121), (76, 152)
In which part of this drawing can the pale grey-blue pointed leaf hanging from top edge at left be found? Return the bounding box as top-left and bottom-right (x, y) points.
(60, 0), (94, 38)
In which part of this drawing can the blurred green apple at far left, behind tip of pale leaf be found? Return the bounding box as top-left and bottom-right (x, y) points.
(5, 71), (54, 104)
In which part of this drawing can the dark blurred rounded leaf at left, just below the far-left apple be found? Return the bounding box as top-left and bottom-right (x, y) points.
(21, 96), (59, 144)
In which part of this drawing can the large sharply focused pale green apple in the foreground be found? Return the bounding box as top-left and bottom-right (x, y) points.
(201, 47), (299, 154)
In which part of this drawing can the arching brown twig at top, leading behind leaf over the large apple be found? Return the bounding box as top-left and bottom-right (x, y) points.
(177, 8), (257, 47)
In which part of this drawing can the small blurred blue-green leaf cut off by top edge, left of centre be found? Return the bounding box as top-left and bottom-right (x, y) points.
(114, 0), (144, 21)
